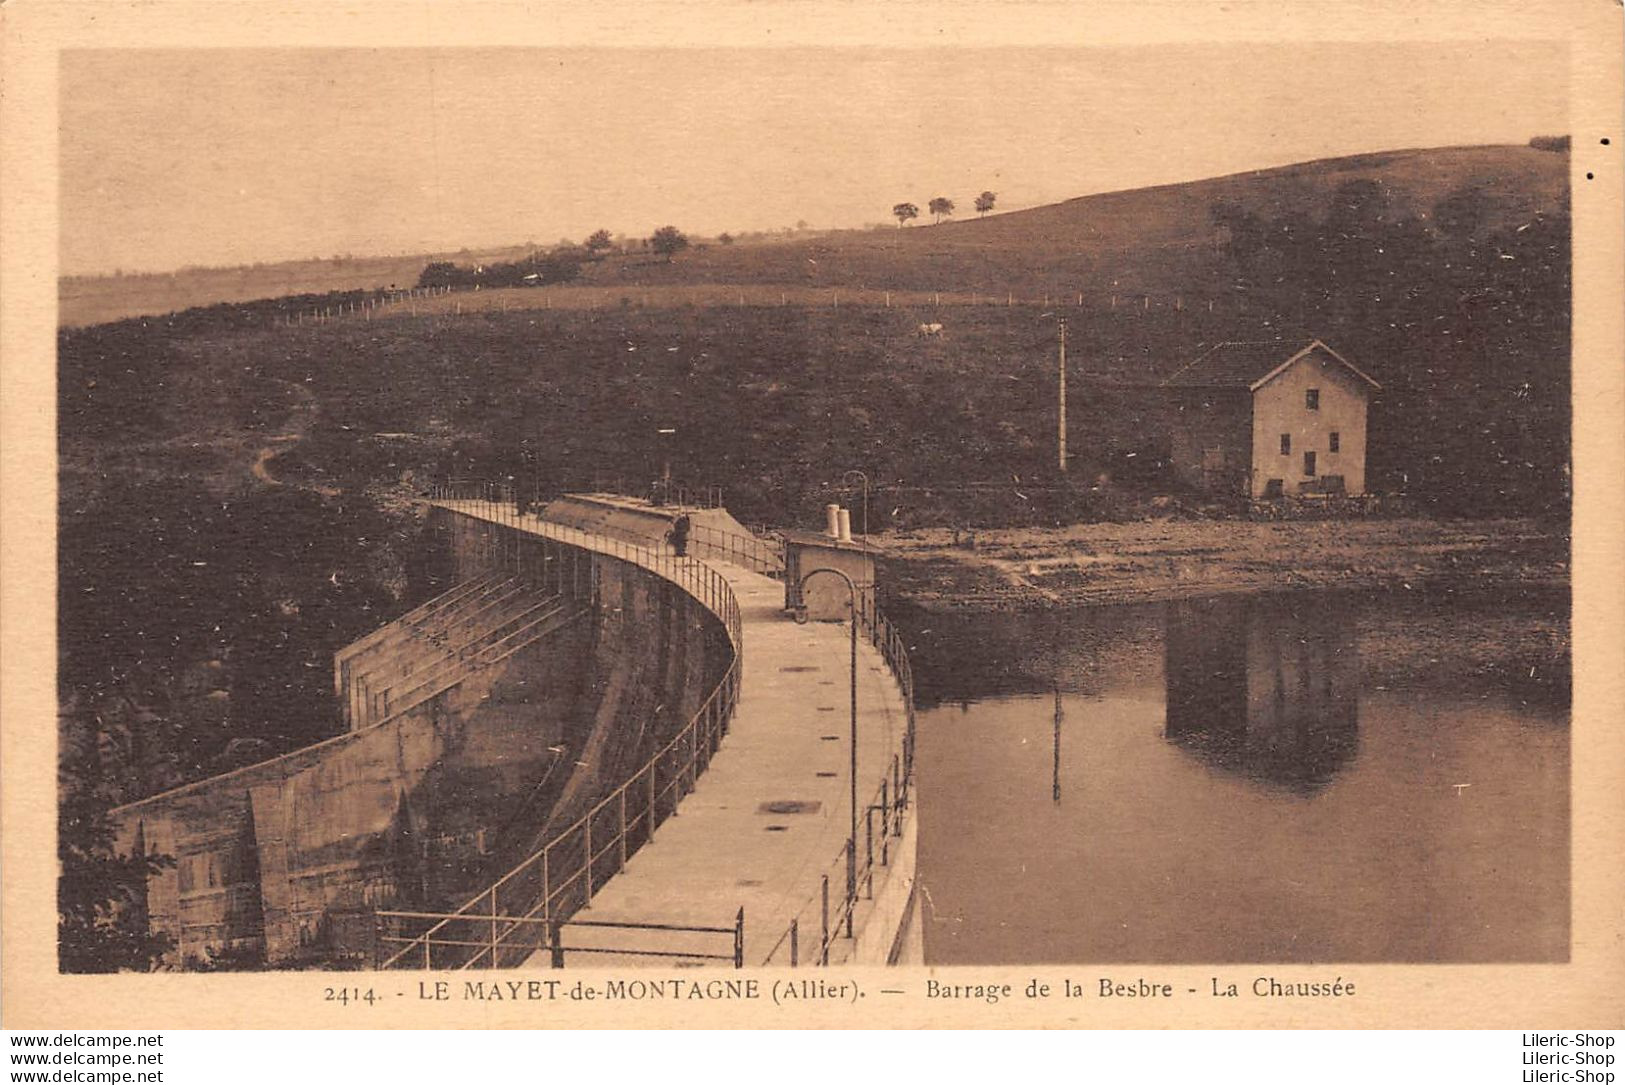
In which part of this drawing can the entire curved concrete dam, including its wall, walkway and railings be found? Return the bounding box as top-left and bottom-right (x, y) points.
(114, 495), (913, 968)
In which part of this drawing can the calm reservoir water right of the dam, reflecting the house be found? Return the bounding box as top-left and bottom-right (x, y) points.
(905, 590), (1570, 965)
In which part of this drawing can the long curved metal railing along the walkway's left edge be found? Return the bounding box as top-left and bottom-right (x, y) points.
(377, 482), (743, 968)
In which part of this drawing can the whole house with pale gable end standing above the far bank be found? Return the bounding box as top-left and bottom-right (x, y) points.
(1164, 339), (1378, 497)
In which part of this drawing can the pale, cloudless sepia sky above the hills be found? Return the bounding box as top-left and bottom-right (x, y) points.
(59, 42), (1568, 274)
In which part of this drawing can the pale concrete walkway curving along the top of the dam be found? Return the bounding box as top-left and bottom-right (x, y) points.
(437, 502), (912, 968)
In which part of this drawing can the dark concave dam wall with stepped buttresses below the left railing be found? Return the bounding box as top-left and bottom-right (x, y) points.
(112, 508), (733, 966)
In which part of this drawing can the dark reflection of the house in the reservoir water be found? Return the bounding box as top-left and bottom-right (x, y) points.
(1165, 596), (1359, 794)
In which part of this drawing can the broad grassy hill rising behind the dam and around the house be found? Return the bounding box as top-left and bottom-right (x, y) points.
(60, 146), (1568, 520)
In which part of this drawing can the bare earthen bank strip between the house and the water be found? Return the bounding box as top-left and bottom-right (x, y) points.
(884, 520), (1568, 609)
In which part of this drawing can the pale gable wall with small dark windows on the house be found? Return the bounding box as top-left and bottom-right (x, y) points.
(1251, 349), (1370, 497)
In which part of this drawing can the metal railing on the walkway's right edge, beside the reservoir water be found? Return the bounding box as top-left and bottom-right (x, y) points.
(761, 594), (915, 968)
